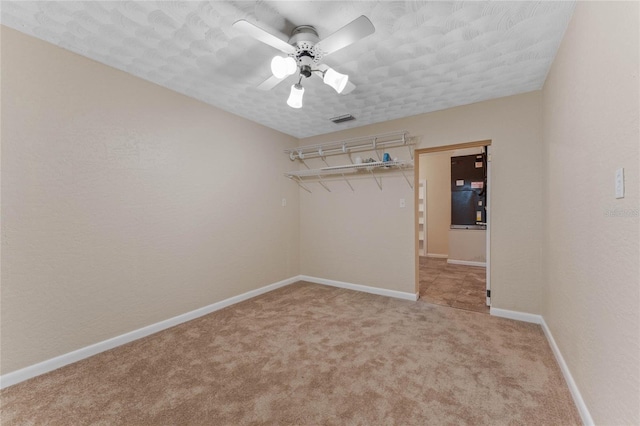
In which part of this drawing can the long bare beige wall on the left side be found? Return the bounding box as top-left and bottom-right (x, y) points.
(1, 27), (299, 374)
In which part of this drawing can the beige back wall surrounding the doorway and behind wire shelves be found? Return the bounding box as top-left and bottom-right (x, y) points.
(300, 92), (542, 313)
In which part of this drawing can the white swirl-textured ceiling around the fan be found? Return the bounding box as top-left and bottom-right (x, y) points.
(1, 1), (574, 138)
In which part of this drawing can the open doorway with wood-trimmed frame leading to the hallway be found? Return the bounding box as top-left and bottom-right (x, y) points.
(414, 140), (491, 313)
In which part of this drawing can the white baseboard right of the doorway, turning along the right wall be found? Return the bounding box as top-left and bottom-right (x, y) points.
(490, 307), (594, 426)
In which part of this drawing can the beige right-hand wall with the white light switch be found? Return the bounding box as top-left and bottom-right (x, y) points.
(542, 2), (640, 425)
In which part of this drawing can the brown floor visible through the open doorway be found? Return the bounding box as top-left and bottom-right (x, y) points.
(420, 257), (489, 313)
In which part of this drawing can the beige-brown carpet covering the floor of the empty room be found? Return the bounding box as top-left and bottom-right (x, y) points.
(0, 283), (580, 426)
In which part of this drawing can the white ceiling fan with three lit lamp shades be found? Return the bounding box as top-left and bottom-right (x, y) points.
(233, 15), (375, 108)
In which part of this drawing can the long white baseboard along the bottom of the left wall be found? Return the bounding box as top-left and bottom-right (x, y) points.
(0, 277), (300, 389)
